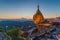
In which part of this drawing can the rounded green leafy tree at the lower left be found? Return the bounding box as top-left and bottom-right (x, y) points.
(6, 28), (19, 40)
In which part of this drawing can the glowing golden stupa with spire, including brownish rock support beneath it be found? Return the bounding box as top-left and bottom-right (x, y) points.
(33, 5), (44, 32)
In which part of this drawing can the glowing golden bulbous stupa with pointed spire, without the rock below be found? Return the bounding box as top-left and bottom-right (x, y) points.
(33, 5), (44, 24)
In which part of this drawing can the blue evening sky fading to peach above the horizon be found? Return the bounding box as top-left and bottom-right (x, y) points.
(0, 0), (60, 19)
